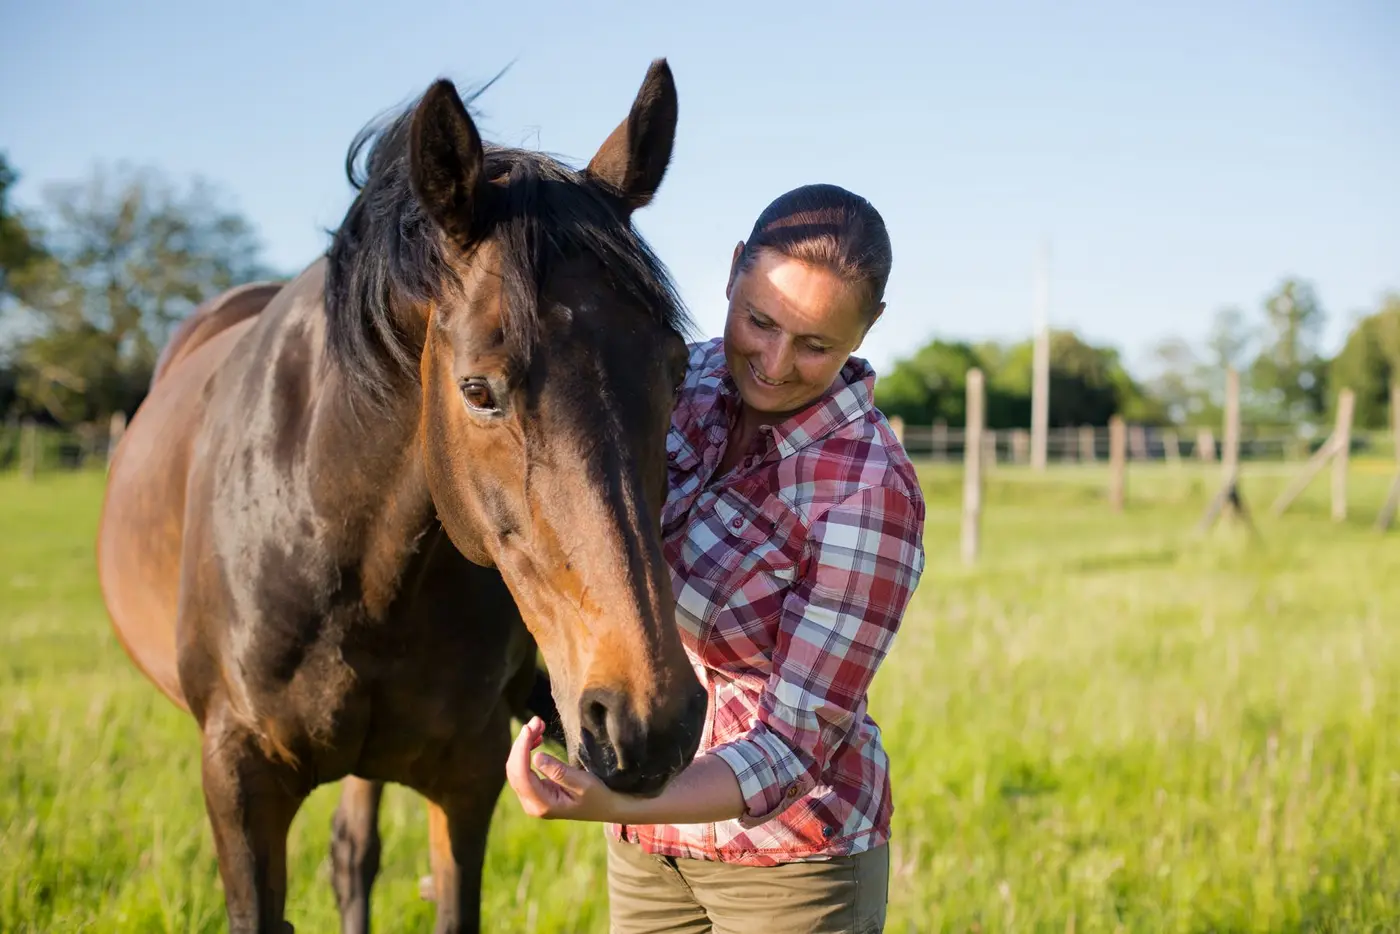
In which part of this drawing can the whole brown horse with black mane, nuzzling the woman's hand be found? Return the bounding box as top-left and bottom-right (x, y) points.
(98, 60), (704, 931)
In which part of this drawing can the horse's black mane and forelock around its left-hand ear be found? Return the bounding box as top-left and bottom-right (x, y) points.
(325, 87), (690, 400)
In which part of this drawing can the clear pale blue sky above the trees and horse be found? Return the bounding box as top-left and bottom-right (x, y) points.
(0, 0), (1400, 378)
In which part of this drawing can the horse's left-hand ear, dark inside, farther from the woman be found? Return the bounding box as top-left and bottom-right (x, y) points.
(409, 78), (486, 246)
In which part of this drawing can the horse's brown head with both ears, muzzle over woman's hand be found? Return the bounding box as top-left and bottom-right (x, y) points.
(327, 62), (704, 793)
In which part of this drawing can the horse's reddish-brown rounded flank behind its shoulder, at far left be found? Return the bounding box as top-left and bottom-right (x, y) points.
(97, 287), (276, 709)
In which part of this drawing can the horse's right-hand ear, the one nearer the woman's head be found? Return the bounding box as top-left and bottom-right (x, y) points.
(588, 59), (678, 210)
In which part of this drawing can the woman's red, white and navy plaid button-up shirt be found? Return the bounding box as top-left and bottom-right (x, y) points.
(608, 339), (924, 865)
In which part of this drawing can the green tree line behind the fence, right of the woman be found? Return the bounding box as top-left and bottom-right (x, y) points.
(875, 277), (1400, 428)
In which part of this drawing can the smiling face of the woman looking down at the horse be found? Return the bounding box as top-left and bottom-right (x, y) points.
(724, 242), (885, 416)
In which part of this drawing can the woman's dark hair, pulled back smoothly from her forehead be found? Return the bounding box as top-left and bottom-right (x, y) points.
(739, 185), (893, 318)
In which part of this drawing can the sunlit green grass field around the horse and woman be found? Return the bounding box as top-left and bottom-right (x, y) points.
(0, 462), (1400, 933)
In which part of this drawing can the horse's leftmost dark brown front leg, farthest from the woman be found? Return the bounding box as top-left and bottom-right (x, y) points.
(203, 711), (307, 934)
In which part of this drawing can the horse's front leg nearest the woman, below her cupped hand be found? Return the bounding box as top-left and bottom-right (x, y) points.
(424, 717), (511, 934)
